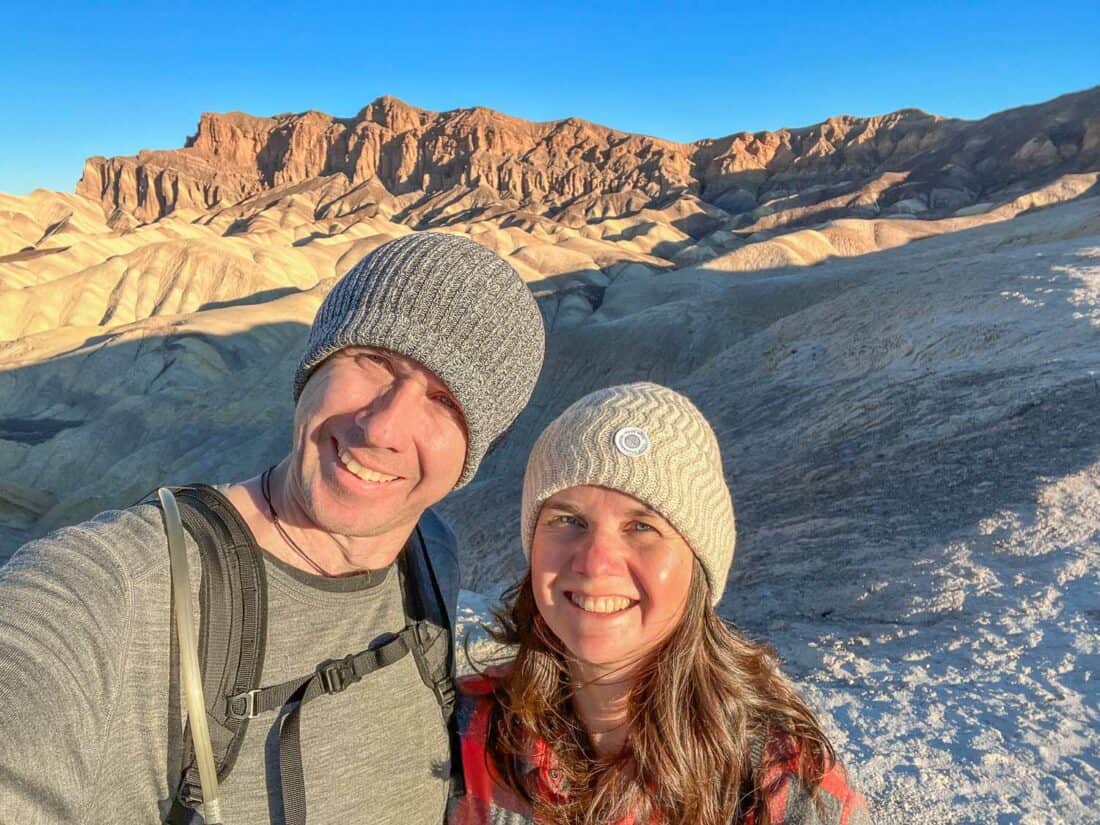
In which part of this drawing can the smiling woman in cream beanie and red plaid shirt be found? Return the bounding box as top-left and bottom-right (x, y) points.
(450, 383), (869, 825)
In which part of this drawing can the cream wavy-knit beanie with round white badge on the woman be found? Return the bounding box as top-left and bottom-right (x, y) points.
(521, 382), (736, 604)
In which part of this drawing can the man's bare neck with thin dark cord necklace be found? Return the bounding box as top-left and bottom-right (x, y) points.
(227, 461), (407, 578)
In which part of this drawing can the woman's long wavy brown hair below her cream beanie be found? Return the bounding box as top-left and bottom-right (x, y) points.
(487, 563), (836, 825)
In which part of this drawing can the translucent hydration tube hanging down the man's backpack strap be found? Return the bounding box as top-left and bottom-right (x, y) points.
(156, 487), (222, 825)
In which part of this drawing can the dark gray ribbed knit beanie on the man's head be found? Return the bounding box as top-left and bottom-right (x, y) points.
(294, 232), (545, 488)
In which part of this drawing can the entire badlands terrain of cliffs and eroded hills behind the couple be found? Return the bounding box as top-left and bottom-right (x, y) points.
(0, 89), (1100, 823)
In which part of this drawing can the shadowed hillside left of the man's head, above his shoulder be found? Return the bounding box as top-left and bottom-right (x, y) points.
(0, 322), (309, 561)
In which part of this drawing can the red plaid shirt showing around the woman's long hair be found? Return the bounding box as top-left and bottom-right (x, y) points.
(447, 675), (871, 825)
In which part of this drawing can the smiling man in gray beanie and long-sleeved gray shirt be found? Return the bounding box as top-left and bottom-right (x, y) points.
(0, 233), (543, 825)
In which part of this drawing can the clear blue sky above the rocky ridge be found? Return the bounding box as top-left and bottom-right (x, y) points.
(0, 0), (1100, 194)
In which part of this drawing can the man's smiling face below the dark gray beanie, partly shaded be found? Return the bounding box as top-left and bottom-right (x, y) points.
(289, 347), (466, 543)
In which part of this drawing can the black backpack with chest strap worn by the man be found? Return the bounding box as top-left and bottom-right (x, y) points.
(153, 484), (462, 825)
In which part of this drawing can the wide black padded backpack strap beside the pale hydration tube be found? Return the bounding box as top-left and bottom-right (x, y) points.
(152, 485), (267, 823)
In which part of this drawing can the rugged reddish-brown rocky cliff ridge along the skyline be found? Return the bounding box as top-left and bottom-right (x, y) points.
(77, 88), (1100, 227)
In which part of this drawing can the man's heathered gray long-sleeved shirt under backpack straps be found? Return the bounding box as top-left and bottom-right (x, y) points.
(0, 505), (450, 825)
